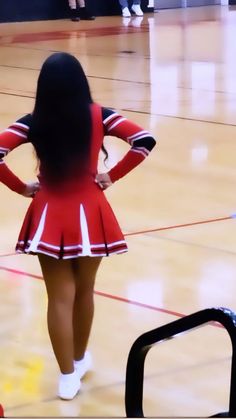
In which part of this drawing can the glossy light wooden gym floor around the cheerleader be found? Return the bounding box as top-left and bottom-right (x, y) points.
(0, 6), (236, 417)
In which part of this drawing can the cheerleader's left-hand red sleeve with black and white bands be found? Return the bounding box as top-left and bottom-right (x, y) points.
(0, 117), (29, 194)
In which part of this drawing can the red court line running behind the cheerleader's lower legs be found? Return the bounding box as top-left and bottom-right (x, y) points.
(0, 266), (223, 328)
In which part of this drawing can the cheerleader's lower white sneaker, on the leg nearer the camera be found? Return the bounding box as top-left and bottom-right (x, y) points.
(58, 371), (81, 400)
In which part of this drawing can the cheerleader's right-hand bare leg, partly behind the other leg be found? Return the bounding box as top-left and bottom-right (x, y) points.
(72, 256), (102, 360)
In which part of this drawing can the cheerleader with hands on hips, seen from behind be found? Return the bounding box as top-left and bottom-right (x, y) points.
(0, 53), (155, 400)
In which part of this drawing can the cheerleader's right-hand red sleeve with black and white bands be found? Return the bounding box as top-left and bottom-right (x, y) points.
(103, 108), (156, 183)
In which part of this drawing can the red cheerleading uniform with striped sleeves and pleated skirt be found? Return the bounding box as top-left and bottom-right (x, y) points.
(0, 103), (155, 259)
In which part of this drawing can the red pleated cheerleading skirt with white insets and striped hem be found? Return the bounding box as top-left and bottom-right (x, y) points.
(16, 182), (127, 259)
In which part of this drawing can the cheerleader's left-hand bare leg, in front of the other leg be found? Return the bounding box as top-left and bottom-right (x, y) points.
(38, 255), (76, 374)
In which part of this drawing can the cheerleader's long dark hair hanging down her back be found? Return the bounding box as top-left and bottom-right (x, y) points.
(29, 52), (93, 182)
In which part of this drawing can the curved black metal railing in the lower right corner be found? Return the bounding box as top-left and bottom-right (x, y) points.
(125, 307), (236, 418)
